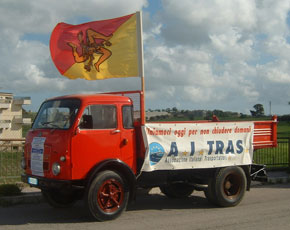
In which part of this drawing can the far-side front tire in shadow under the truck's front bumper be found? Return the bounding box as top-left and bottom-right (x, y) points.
(41, 189), (78, 208)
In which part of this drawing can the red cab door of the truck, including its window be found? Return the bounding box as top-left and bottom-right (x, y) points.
(71, 104), (121, 179)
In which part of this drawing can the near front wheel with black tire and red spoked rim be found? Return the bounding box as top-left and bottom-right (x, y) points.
(86, 170), (129, 221)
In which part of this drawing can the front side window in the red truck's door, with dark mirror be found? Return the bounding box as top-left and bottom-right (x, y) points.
(80, 105), (117, 129)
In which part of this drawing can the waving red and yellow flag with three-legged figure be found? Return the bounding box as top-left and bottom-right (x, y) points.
(50, 14), (139, 80)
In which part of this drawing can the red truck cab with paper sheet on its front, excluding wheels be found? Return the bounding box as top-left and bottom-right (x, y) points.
(25, 95), (136, 180)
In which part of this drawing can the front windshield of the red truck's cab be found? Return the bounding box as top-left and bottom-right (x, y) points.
(32, 99), (81, 129)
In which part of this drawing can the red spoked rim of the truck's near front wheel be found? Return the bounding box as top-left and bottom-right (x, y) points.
(98, 179), (124, 213)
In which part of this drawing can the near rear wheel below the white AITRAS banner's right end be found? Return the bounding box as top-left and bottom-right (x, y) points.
(213, 167), (247, 207)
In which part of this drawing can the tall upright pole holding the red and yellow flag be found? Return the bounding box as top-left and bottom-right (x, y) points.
(136, 11), (145, 125)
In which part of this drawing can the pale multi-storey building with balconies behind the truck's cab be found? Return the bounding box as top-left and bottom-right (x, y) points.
(0, 92), (31, 140)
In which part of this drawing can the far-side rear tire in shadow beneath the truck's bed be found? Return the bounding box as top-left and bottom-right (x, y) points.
(159, 183), (194, 198)
